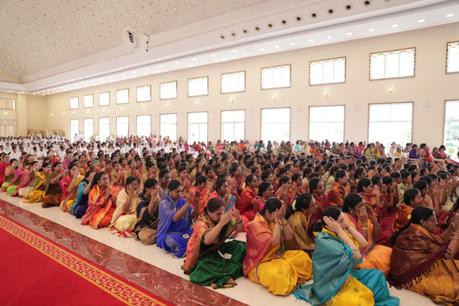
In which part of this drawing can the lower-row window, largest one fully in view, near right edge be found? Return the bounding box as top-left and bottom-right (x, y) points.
(368, 103), (413, 148)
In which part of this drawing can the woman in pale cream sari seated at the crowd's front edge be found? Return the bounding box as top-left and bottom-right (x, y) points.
(110, 176), (140, 237)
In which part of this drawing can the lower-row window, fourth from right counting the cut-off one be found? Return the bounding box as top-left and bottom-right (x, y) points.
(261, 108), (290, 142)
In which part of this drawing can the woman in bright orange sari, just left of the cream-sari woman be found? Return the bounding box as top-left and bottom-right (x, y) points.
(81, 172), (116, 229)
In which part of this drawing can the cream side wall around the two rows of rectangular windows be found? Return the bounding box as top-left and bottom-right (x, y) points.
(40, 23), (459, 145)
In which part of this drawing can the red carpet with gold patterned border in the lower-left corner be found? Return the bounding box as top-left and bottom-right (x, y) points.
(0, 215), (172, 306)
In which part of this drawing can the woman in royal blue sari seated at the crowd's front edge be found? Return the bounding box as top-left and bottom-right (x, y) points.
(156, 180), (199, 258)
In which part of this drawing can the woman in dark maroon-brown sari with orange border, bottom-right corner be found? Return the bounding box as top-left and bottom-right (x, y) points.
(389, 206), (459, 305)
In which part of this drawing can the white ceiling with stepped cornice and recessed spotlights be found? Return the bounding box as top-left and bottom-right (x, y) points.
(0, 0), (459, 94)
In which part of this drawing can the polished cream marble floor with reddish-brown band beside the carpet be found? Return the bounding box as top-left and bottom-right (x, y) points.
(0, 193), (435, 306)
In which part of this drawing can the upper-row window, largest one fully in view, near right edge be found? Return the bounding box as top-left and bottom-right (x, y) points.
(370, 48), (416, 80)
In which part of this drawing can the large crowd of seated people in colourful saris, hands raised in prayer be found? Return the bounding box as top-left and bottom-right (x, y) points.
(0, 136), (459, 305)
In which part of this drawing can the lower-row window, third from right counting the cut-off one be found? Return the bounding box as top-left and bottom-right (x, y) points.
(309, 105), (344, 142)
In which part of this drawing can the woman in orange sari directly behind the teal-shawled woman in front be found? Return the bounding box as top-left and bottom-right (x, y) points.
(342, 193), (392, 275)
